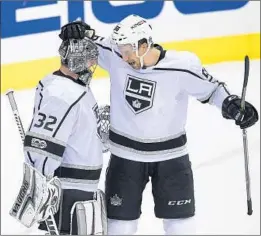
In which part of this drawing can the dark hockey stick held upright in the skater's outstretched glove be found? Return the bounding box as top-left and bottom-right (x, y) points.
(241, 56), (253, 215)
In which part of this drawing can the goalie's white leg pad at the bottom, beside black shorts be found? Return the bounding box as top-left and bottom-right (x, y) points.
(70, 190), (107, 235)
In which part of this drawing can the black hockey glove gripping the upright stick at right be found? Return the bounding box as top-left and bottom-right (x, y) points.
(222, 95), (258, 129)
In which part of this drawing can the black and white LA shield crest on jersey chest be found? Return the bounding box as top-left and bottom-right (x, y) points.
(124, 75), (156, 114)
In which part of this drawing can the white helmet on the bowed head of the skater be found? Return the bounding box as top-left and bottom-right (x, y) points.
(111, 15), (153, 66)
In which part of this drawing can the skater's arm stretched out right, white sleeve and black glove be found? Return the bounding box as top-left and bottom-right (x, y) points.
(180, 53), (258, 128)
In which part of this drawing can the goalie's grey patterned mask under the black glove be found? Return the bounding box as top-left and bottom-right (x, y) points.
(59, 37), (99, 85)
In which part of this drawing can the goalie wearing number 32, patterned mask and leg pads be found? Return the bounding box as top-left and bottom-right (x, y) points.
(11, 37), (107, 235)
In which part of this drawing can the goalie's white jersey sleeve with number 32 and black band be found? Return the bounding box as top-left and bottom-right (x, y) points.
(24, 92), (77, 176)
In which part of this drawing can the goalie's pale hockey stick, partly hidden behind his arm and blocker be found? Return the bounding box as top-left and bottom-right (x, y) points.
(6, 90), (59, 235)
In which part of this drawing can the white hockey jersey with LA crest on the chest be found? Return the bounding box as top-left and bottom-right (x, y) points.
(95, 37), (229, 162)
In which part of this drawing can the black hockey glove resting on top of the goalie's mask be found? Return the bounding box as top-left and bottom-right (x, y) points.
(59, 21), (95, 40)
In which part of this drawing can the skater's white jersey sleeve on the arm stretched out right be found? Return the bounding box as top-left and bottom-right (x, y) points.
(180, 53), (230, 108)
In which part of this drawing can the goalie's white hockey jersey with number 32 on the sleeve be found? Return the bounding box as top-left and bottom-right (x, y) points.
(24, 71), (103, 191)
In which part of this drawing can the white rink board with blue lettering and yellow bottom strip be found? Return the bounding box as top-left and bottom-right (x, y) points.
(1, 0), (260, 92)
